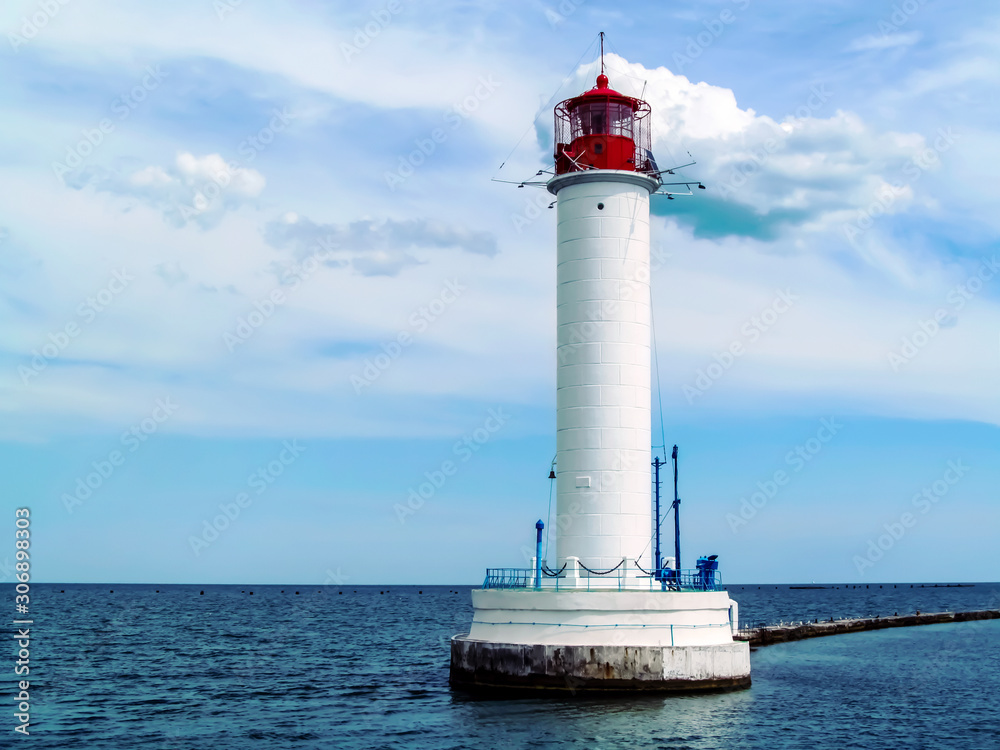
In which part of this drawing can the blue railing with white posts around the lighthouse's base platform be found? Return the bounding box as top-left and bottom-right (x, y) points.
(483, 560), (723, 591)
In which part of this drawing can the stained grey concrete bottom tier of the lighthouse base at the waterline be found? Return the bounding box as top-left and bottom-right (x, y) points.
(451, 635), (750, 693)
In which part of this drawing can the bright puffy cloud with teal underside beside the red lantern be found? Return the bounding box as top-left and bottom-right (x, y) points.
(577, 55), (926, 244)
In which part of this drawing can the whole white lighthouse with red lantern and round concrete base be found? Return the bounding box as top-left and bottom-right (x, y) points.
(451, 59), (750, 691)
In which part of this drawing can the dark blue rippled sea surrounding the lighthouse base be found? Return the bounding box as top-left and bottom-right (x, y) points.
(7, 584), (1000, 750)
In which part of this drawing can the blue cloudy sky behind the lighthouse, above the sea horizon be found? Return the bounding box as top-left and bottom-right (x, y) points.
(0, 0), (1000, 585)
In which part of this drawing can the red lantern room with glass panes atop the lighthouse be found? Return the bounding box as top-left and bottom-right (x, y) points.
(555, 71), (656, 175)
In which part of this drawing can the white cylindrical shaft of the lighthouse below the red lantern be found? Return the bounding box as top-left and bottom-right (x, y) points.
(549, 170), (657, 570)
